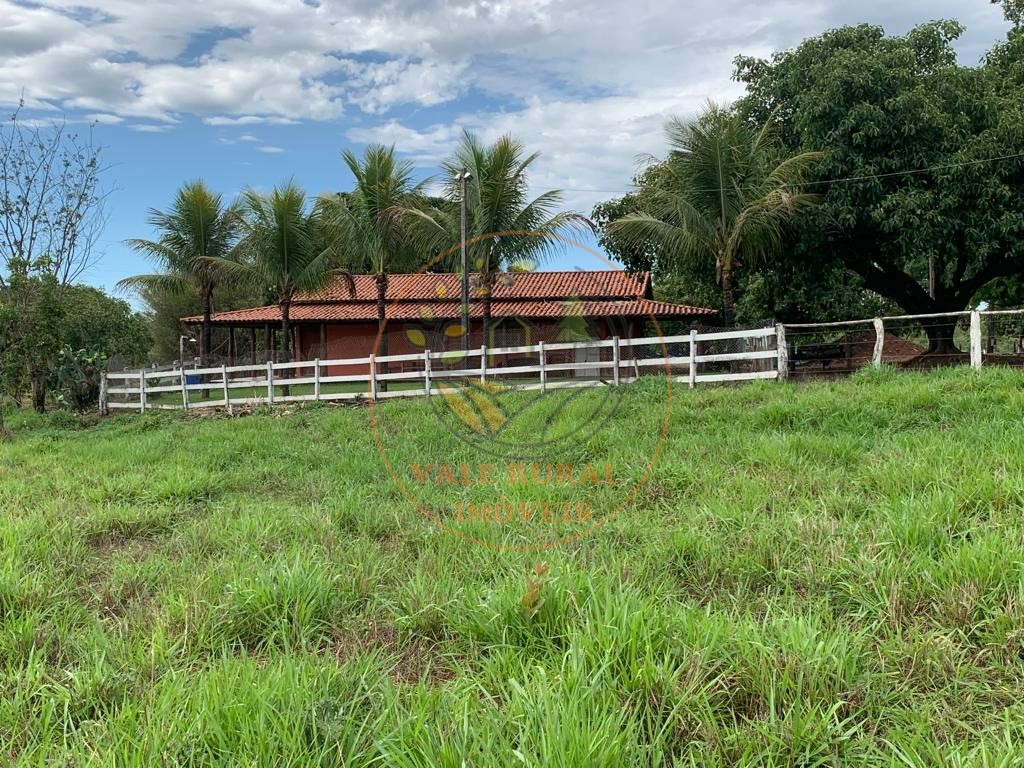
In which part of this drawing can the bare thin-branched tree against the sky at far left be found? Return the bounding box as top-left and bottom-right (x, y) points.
(0, 102), (109, 287)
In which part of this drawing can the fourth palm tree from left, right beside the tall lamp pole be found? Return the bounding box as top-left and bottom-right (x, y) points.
(411, 131), (591, 339)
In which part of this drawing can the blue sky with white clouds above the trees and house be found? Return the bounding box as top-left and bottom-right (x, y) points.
(0, 0), (1006, 303)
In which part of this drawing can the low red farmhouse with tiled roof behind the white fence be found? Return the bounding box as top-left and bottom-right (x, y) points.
(183, 270), (715, 375)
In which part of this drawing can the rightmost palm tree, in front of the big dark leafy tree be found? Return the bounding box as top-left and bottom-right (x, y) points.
(607, 103), (822, 326)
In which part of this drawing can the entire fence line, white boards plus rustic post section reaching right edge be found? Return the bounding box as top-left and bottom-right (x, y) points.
(100, 309), (1024, 413)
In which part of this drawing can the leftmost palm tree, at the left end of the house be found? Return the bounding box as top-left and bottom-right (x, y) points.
(117, 180), (238, 362)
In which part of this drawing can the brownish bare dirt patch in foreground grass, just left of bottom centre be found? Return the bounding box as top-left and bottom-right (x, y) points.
(333, 623), (456, 686)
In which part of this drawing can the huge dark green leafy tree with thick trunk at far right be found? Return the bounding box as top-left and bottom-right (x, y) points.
(736, 20), (1024, 352)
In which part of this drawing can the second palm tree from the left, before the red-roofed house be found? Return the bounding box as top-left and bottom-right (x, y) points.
(209, 182), (335, 362)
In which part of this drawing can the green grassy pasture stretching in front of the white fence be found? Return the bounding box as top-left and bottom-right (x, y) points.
(0, 370), (1024, 768)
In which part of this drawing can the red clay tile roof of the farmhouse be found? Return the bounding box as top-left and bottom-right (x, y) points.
(184, 270), (715, 325)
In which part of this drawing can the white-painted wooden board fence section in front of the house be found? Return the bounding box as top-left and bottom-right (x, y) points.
(99, 327), (785, 414)
